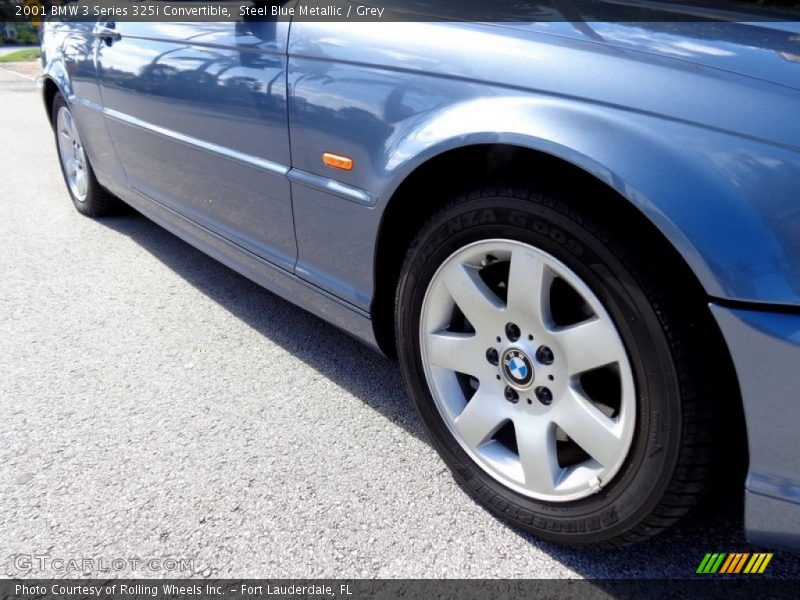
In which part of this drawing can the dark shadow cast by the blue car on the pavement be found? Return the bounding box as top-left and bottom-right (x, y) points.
(99, 210), (800, 578)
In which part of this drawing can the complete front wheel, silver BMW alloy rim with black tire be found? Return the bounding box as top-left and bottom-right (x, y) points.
(396, 190), (711, 546)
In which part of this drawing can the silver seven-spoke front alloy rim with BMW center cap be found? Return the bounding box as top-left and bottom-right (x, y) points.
(420, 239), (636, 502)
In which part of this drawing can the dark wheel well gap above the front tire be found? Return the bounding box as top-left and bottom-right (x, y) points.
(372, 144), (748, 489)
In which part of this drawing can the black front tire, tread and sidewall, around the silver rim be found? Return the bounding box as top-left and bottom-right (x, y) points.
(395, 187), (714, 548)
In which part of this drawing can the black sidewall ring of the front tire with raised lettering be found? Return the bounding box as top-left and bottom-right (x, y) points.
(396, 195), (681, 542)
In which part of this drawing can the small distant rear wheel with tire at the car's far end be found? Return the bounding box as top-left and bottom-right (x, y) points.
(52, 94), (119, 217)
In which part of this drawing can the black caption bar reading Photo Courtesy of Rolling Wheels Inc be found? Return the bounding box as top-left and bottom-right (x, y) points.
(0, 575), (798, 600)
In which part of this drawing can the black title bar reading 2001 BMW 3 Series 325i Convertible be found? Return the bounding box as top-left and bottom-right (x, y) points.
(0, 0), (800, 25)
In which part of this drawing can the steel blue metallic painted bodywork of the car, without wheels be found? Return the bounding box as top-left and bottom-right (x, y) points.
(43, 12), (800, 545)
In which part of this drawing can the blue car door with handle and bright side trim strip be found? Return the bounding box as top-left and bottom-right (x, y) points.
(97, 21), (297, 269)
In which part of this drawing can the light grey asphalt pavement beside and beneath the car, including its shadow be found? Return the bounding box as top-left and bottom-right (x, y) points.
(0, 70), (800, 578)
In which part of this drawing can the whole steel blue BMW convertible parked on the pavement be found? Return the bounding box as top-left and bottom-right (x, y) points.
(41, 2), (800, 547)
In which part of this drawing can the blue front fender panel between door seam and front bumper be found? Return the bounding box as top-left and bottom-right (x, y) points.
(289, 22), (800, 305)
